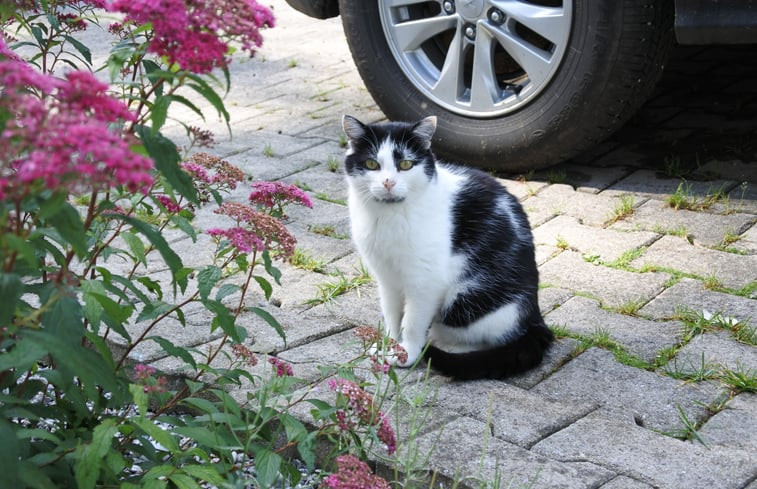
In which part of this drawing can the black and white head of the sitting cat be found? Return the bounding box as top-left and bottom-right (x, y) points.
(342, 115), (436, 203)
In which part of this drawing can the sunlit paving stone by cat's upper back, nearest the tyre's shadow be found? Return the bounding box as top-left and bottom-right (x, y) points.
(523, 184), (632, 227)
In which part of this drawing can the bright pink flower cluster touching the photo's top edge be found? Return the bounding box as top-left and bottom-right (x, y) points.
(108, 0), (274, 73)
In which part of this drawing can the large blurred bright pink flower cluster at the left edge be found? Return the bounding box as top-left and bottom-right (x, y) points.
(0, 44), (153, 200)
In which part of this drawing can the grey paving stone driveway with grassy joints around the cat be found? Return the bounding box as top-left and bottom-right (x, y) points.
(133, 0), (757, 489)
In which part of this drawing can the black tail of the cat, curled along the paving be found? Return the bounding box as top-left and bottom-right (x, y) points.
(425, 318), (554, 380)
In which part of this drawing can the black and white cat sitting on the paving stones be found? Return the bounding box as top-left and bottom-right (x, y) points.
(342, 116), (553, 379)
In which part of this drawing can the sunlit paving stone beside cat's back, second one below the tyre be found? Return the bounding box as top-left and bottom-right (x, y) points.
(533, 216), (658, 262)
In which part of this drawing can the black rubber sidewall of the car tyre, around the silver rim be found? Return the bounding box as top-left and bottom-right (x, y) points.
(340, 0), (636, 168)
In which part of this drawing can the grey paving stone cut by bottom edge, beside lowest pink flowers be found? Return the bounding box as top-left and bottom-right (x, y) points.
(390, 417), (615, 489)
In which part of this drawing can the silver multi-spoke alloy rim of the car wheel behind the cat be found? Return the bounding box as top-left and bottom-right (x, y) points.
(379, 0), (572, 118)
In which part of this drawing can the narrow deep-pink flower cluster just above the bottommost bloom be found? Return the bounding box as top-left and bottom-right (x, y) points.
(328, 378), (397, 455)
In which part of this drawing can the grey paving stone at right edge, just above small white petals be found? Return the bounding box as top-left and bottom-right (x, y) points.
(639, 278), (757, 323)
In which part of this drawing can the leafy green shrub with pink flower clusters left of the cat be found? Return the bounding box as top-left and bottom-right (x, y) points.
(0, 0), (410, 489)
